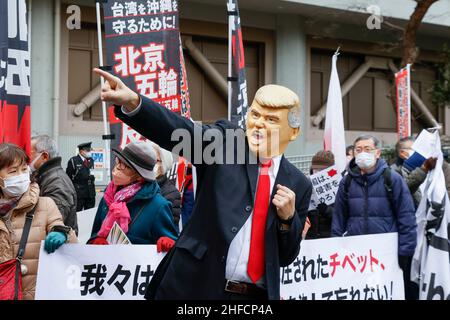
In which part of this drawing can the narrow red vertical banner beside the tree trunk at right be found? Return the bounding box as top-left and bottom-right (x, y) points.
(395, 64), (411, 139)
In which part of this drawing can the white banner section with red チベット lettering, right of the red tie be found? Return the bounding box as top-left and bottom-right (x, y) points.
(280, 233), (404, 300)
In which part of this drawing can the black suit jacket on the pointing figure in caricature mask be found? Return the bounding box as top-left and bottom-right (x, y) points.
(115, 97), (312, 299)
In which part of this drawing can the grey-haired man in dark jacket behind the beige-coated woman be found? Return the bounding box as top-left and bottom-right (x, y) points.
(30, 135), (78, 235)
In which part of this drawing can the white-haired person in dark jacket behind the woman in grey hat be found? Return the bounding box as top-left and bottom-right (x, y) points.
(153, 143), (181, 227)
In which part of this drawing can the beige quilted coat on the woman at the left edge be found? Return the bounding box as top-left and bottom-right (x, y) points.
(0, 183), (77, 300)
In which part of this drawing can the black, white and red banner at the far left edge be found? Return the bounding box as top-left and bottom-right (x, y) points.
(0, 0), (31, 154)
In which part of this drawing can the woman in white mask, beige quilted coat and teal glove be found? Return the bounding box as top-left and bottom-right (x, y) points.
(0, 143), (77, 300)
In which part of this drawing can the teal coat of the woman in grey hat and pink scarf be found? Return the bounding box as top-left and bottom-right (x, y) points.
(89, 181), (178, 244)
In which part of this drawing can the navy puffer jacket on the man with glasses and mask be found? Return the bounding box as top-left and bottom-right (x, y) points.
(331, 159), (417, 256)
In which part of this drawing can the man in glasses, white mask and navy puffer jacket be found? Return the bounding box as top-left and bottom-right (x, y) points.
(331, 135), (417, 299)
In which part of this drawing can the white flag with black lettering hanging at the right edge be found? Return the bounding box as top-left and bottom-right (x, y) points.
(411, 131), (450, 300)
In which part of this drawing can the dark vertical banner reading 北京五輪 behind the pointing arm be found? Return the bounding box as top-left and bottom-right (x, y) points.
(103, 0), (189, 154)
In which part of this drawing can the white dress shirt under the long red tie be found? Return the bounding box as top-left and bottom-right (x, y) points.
(225, 155), (282, 287)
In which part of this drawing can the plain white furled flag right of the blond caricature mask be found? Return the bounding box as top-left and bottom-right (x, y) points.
(323, 53), (347, 172)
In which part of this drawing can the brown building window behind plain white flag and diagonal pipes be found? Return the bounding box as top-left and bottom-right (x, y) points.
(310, 49), (442, 133)
